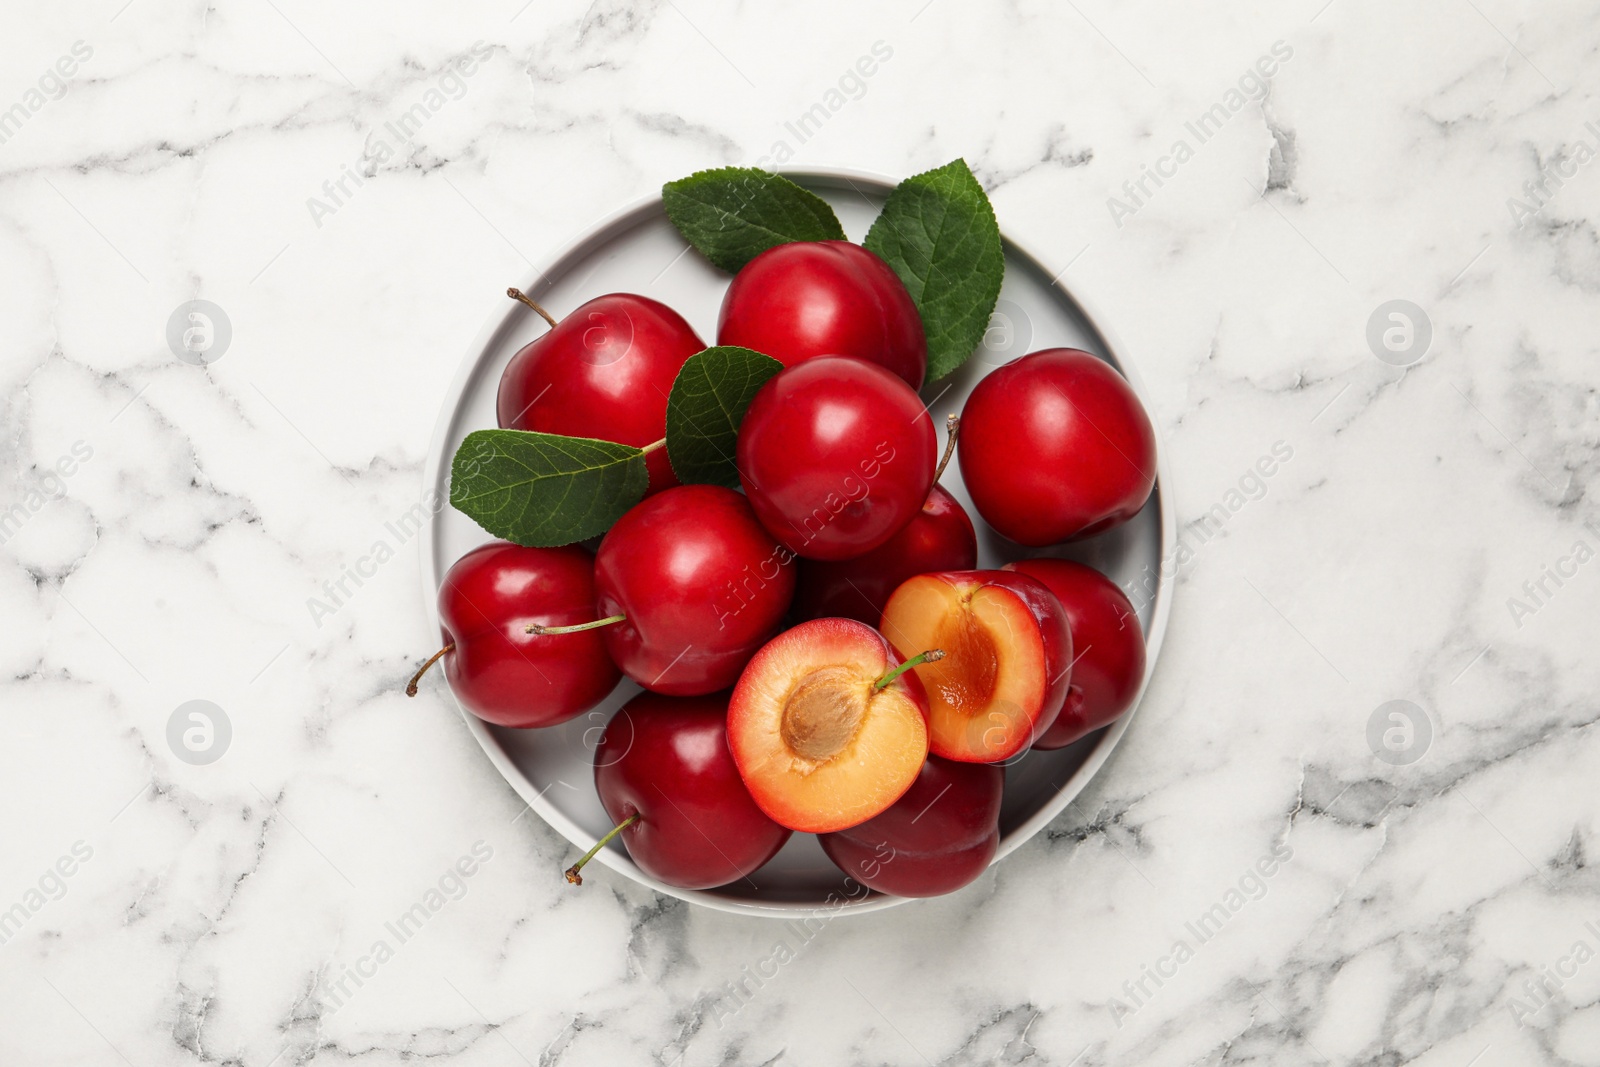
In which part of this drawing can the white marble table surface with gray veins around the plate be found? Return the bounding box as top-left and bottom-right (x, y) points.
(0, 0), (1600, 1067)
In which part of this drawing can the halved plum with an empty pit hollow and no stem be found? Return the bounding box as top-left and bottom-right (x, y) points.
(880, 571), (1072, 763)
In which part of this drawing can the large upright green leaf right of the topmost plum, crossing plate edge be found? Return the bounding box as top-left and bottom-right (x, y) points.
(862, 160), (1005, 382)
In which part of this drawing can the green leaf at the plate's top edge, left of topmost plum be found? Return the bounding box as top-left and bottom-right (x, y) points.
(661, 166), (845, 274)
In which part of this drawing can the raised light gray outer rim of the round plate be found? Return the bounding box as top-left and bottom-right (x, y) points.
(419, 165), (1178, 918)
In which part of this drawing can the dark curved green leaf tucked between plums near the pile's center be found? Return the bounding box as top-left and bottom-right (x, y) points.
(667, 344), (784, 490)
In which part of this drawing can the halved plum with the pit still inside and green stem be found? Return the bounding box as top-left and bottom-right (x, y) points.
(728, 619), (928, 833)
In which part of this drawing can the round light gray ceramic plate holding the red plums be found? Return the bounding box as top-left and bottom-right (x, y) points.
(422, 170), (1174, 917)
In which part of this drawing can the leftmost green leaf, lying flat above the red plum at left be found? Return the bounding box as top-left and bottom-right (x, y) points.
(450, 430), (650, 547)
